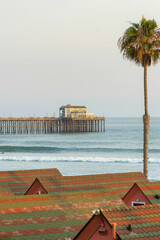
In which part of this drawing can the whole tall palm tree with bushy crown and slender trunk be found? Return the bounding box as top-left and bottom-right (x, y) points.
(118, 17), (160, 177)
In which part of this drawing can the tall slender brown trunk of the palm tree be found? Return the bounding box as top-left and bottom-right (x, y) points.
(143, 64), (150, 178)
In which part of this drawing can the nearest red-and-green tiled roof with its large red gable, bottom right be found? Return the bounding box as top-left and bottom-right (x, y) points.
(74, 205), (160, 240)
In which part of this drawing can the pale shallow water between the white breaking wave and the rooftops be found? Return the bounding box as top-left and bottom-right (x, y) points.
(0, 161), (160, 181)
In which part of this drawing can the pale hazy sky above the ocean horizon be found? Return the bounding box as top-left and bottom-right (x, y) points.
(0, 0), (160, 117)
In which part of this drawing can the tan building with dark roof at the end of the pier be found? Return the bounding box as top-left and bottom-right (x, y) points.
(59, 105), (94, 118)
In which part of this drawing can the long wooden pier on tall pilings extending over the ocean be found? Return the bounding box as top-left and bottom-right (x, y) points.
(0, 117), (105, 135)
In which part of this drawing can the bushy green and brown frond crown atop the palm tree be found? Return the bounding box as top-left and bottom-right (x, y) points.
(118, 17), (160, 66)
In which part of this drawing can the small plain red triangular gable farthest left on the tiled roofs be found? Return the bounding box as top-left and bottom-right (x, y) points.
(25, 178), (48, 195)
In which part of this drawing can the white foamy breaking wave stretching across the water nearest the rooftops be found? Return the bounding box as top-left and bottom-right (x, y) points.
(0, 156), (160, 164)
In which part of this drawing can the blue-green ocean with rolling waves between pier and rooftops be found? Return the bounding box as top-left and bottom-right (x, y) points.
(0, 118), (160, 181)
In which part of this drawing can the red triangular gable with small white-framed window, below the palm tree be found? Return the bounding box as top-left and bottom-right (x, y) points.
(122, 183), (151, 206)
